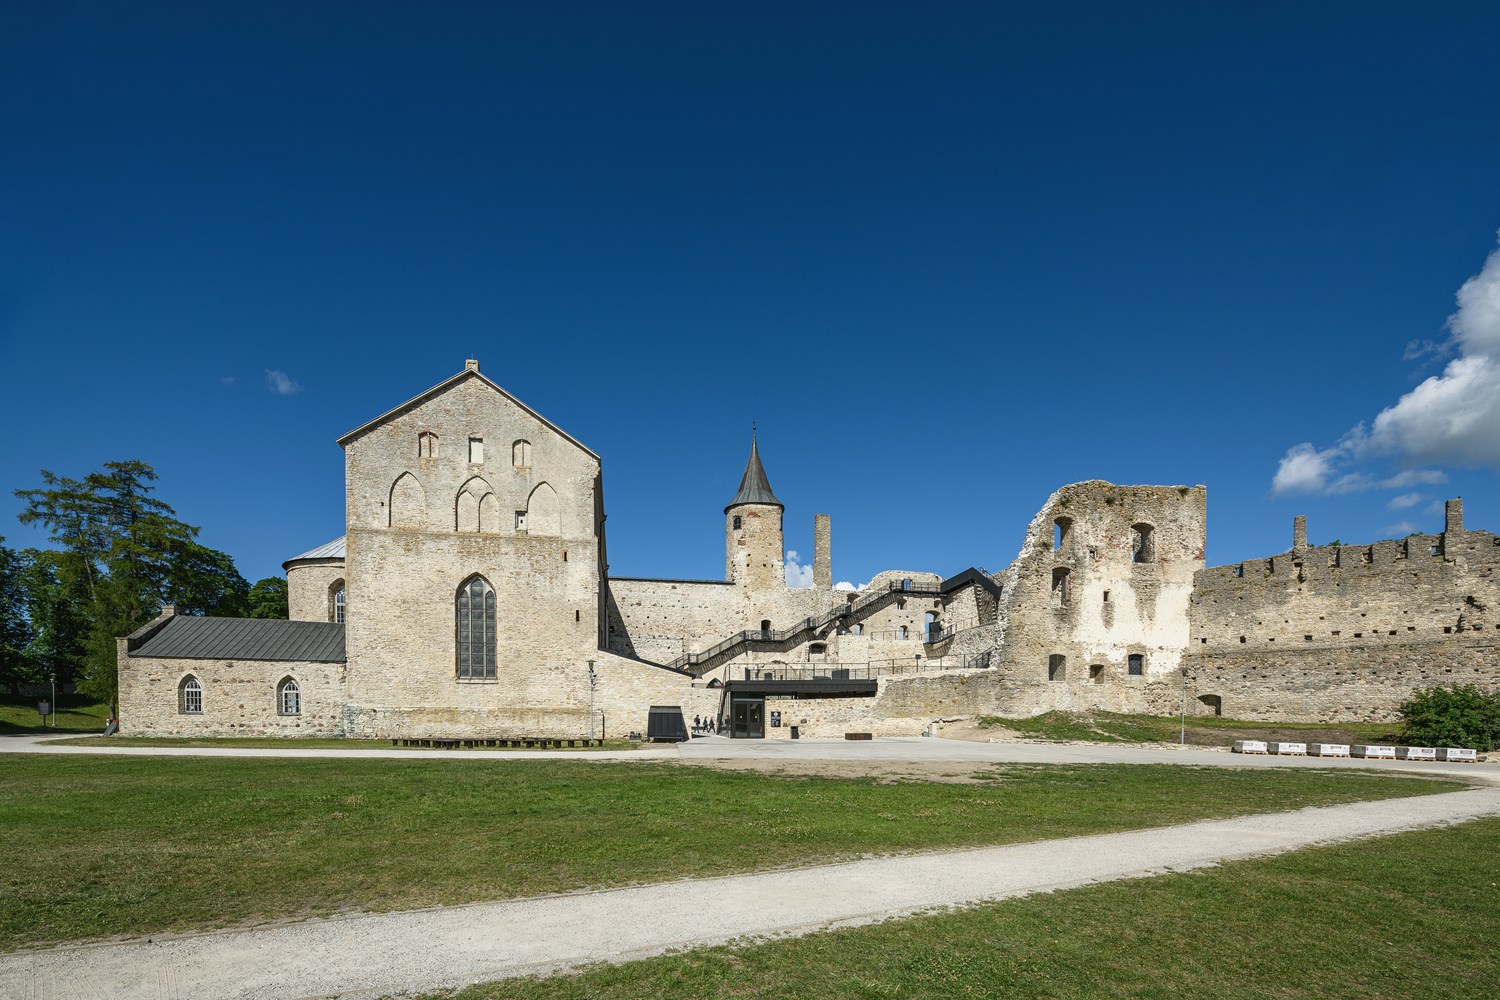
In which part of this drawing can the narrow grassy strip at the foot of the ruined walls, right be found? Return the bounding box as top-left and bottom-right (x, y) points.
(980, 712), (1401, 747)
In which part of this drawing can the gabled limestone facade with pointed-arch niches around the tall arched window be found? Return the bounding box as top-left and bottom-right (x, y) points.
(341, 372), (600, 736)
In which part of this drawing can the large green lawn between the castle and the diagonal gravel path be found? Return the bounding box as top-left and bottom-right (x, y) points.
(0, 756), (1461, 949)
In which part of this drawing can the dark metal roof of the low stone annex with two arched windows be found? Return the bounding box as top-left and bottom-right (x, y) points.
(131, 615), (345, 663)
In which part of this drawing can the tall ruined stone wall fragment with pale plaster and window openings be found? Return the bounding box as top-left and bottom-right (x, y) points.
(993, 480), (1208, 717)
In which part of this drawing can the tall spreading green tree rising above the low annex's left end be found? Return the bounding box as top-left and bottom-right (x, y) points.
(15, 462), (249, 709)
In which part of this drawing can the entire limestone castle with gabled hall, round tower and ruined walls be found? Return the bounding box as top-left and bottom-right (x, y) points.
(119, 361), (1500, 738)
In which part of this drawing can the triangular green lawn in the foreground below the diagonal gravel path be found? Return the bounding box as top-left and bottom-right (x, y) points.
(431, 820), (1500, 1000)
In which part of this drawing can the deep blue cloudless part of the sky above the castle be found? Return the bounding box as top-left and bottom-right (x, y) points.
(0, 1), (1500, 583)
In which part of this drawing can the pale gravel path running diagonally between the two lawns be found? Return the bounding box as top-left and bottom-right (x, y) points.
(0, 779), (1500, 1000)
